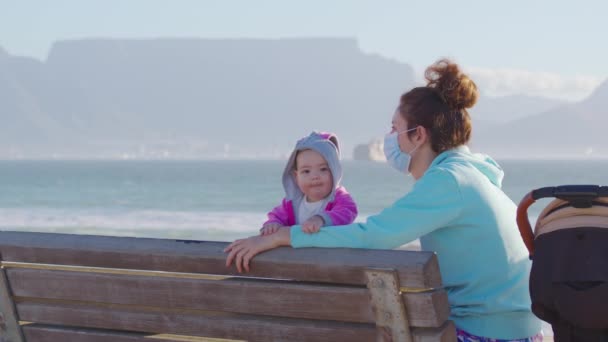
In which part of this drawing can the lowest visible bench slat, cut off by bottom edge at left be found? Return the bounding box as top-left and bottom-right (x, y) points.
(23, 324), (154, 342)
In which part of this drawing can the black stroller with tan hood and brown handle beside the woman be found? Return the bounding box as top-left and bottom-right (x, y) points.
(517, 185), (608, 342)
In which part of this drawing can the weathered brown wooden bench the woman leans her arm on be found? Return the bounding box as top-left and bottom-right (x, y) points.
(0, 231), (456, 342)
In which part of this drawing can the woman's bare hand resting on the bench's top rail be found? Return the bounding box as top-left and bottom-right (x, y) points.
(224, 227), (291, 273)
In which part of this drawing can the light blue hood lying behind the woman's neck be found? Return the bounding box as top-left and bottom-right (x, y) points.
(429, 145), (505, 188)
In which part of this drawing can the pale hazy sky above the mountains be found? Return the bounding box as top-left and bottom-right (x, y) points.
(0, 0), (608, 100)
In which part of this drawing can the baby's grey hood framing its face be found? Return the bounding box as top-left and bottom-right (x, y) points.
(283, 131), (342, 200)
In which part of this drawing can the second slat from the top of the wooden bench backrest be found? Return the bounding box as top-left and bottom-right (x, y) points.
(8, 269), (449, 327)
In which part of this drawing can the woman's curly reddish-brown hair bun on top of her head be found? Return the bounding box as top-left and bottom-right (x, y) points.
(424, 59), (479, 110)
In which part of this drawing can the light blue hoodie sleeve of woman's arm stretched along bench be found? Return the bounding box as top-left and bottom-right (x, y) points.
(291, 169), (463, 249)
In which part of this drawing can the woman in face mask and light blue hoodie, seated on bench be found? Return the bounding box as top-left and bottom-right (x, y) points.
(226, 60), (542, 341)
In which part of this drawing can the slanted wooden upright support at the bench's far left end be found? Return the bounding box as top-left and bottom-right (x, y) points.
(0, 268), (23, 342)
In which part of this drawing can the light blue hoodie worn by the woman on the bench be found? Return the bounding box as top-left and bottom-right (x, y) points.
(291, 146), (541, 339)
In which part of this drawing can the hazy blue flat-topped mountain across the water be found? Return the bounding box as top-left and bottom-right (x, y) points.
(0, 39), (413, 158)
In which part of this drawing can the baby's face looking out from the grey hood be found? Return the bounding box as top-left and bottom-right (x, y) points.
(294, 150), (334, 202)
